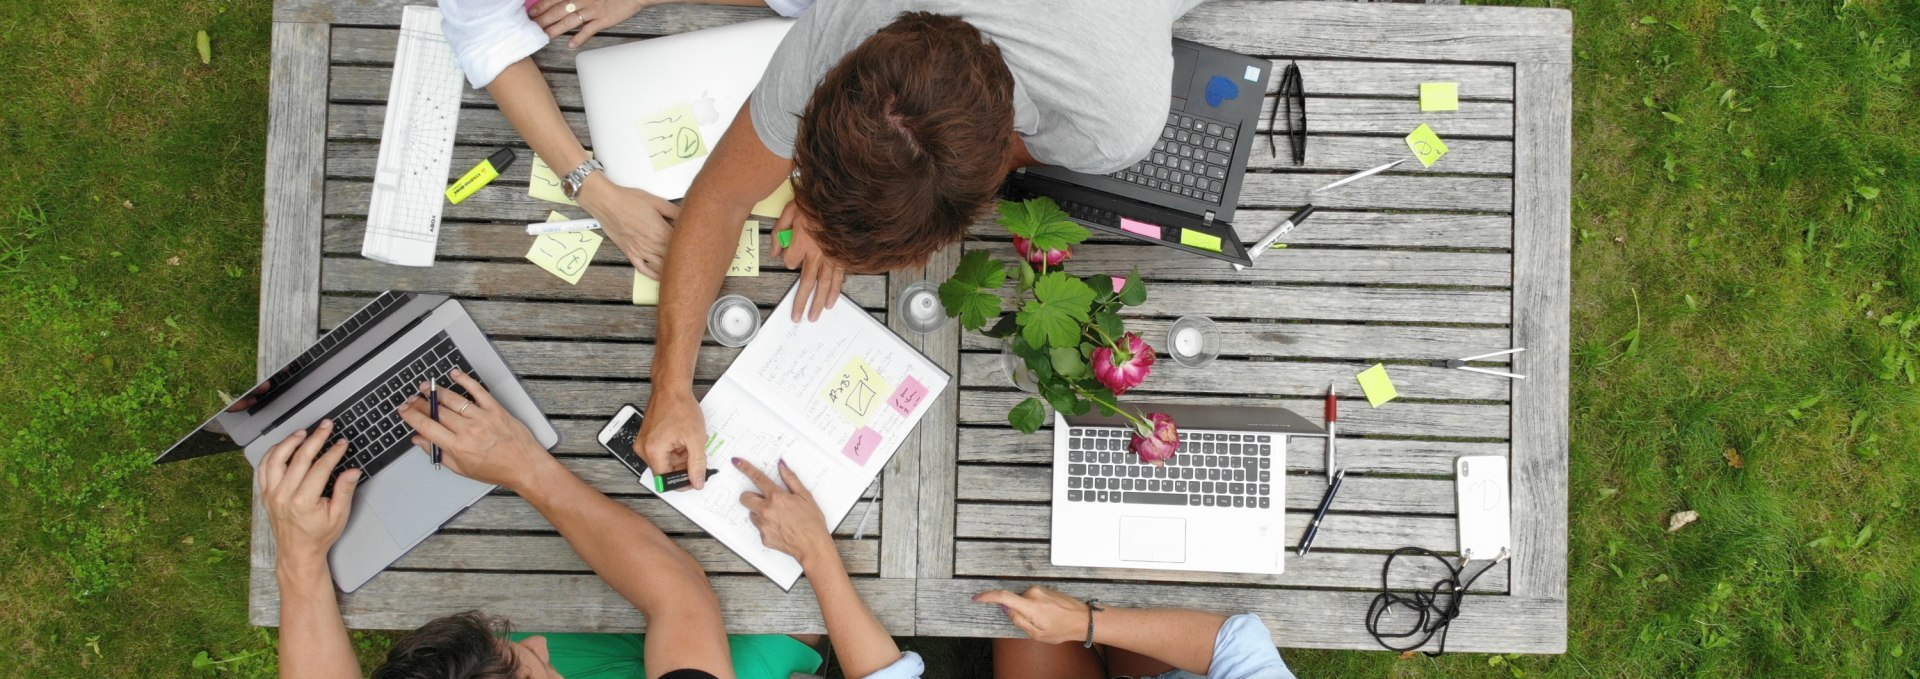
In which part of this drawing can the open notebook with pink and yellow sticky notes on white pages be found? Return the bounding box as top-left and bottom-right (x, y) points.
(641, 283), (950, 589)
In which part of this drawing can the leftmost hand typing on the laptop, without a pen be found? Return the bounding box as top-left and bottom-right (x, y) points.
(253, 420), (361, 568)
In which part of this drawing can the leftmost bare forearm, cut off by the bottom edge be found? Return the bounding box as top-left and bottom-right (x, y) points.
(275, 554), (361, 679)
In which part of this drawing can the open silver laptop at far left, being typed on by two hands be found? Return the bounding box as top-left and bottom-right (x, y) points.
(154, 292), (561, 591)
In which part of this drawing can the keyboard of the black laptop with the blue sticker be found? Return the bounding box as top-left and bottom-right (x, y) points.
(1108, 113), (1240, 203)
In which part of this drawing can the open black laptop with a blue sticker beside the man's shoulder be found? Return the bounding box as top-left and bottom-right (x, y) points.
(1004, 40), (1271, 265)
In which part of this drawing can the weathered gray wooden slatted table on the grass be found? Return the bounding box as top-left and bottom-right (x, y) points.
(252, 0), (1572, 652)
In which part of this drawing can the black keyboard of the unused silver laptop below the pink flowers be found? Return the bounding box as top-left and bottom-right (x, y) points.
(1068, 428), (1284, 508)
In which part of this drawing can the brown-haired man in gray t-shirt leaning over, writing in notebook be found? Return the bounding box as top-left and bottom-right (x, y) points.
(634, 0), (1200, 487)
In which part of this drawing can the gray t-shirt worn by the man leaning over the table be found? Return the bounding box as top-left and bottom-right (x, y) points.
(753, 0), (1204, 175)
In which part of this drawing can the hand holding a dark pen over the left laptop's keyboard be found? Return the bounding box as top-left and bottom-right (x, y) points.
(399, 368), (553, 493)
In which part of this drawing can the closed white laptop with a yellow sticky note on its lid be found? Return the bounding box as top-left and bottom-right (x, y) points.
(572, 19), (793, 199)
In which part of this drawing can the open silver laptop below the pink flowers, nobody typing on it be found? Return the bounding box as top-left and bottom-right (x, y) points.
(1052, 403), (1327, 575)
